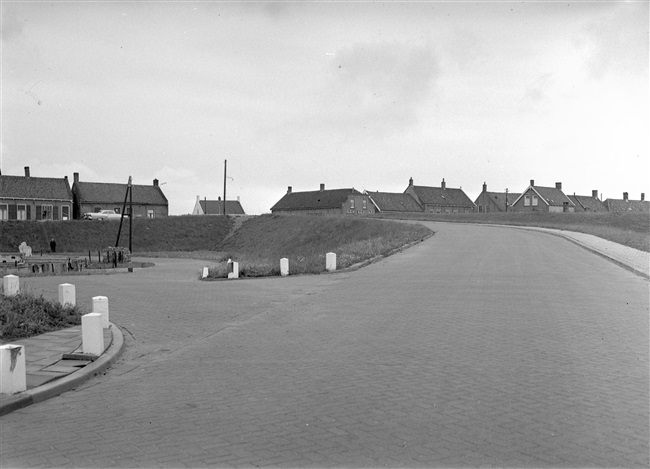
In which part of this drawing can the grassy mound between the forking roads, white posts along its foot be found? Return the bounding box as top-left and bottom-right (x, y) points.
(209, 215), (431, 278)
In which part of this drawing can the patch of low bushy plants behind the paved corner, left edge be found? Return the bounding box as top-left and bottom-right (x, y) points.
(0, 293), (84, 343)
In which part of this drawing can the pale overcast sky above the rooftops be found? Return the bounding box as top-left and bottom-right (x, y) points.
(0, 1), (650, 214)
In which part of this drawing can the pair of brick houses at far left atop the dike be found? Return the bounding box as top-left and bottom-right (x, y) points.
(0, 166), (169, 220)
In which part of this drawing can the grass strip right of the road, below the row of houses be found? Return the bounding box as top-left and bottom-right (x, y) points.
(370, 212), (650, 252)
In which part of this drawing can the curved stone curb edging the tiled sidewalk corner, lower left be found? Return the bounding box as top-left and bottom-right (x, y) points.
(0, 323), (124, 416)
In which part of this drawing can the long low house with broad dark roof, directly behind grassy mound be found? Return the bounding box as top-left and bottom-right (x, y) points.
(271, 184), (375, 215)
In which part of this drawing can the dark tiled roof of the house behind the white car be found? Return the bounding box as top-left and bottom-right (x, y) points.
(72, 182), (167, 205)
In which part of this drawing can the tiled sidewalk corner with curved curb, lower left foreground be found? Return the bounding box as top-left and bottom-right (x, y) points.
(0, 324), (124, 416)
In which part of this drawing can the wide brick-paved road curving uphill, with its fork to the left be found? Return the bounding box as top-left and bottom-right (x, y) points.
(0, 224), (649, 467)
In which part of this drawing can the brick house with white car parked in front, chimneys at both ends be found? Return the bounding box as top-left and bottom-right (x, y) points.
(72, 173), (169, 219)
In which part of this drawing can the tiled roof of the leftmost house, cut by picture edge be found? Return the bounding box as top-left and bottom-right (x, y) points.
(0, 176), (72, 201)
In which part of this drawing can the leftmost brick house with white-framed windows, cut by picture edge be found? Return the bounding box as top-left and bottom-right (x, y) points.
(0, 166), (73, 221)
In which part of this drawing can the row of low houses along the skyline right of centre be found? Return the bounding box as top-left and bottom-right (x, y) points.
(271, 178), (650, 215)
